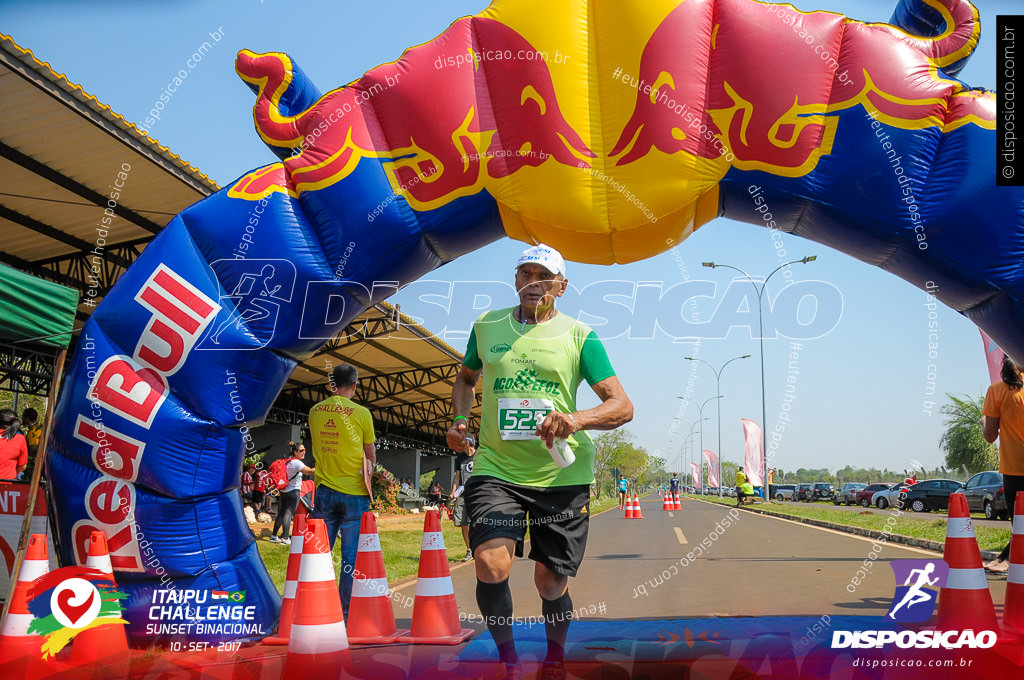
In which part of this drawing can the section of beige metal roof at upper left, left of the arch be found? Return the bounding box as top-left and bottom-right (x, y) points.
(0, 34), (219, 318)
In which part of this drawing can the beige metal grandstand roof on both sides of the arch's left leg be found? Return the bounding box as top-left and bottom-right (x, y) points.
(0, 34), (479, 447)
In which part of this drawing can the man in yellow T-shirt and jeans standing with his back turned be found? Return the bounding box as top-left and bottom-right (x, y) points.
(309, 364), (377, 617)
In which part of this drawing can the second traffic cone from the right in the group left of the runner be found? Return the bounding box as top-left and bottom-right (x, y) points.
(348, 512), (409, 644)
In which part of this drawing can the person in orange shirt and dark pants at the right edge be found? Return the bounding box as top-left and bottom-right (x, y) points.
(981, 356), (1024, 573)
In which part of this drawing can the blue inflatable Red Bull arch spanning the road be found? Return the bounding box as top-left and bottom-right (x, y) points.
(47, 0), (1007, 642)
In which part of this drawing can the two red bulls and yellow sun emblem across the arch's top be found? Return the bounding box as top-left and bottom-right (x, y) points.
(229, 0), (995, 249)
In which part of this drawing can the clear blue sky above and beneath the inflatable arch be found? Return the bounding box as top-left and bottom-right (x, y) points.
(0, 0), (1007, 481)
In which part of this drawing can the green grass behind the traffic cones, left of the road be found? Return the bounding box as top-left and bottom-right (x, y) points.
(256, 498), (617, 594)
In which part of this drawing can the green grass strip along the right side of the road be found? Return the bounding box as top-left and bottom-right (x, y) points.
(692, 496), (1010, 550)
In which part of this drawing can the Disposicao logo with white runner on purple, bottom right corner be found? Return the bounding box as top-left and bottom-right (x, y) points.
(831, 559), (996, 649)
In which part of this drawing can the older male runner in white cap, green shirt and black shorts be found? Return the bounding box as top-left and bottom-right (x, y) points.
(447, 245), (633, 678)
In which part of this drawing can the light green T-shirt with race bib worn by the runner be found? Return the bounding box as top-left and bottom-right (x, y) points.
(464, 307), (615, 487)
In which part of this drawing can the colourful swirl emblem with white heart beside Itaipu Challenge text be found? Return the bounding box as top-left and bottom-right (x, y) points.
(29, 566), (128, 658)
